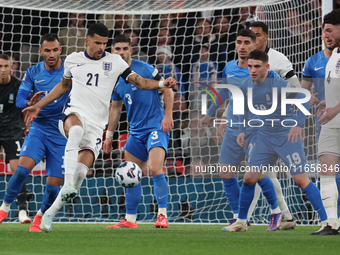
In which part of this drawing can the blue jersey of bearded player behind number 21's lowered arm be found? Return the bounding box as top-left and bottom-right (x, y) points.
(19, 60), (70, 137)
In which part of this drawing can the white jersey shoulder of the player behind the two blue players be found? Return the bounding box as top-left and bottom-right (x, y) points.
(267, 48), (294, 78)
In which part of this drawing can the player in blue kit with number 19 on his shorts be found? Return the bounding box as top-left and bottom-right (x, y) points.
(225, 50), (327, 232)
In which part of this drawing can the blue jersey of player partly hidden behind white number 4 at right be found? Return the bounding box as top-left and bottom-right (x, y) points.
(302, 51), (329, 101)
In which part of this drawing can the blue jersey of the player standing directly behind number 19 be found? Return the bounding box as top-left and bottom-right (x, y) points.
(207, 60), (250, 132)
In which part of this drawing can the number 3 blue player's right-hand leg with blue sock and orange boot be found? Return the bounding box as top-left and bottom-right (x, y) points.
(148, 147), (169, 228)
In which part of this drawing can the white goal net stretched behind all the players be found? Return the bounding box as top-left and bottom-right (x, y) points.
(0, 0), (322, 224)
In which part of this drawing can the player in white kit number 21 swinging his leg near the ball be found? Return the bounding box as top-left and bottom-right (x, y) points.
(24, 23), (176, 232)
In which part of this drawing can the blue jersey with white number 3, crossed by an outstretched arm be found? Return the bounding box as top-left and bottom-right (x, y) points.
(111, 59), (164, 134)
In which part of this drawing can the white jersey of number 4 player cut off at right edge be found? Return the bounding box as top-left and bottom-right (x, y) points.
(325, 48), (340, 128)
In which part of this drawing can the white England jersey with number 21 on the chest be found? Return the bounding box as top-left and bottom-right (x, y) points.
(64, 52), (129, 129)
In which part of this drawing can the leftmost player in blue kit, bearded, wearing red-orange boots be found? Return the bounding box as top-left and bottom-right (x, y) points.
(0, 34), (69, 232)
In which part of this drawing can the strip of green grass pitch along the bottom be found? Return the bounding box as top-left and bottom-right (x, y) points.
(0, 223), (340, 255)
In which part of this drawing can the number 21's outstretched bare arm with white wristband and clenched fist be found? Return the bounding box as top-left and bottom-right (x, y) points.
(128, 73), (177, 90)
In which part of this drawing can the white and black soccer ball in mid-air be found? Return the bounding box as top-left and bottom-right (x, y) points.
(116, 161), (142, 188)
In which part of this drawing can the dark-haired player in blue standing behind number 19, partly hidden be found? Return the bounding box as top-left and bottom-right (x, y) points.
(200, 29), (257, 225)
